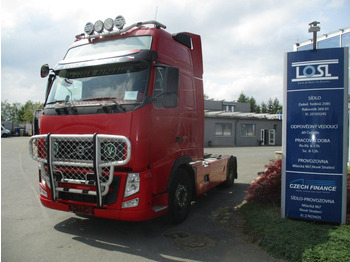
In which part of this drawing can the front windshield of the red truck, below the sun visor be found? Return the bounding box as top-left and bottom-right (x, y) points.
(47, 62), (150, 105)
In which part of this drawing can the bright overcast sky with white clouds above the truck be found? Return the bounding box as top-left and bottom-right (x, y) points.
(1, 0), (350, 103)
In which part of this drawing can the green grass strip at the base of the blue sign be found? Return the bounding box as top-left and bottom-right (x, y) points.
(238, 202), (350, 262)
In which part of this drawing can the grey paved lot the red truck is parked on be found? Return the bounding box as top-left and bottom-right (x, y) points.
(1, 137), (280, 262)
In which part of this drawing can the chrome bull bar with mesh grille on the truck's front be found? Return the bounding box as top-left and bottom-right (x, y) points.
(29, 134), (131, 207)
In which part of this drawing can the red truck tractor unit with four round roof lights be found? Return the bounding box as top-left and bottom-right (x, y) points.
(29, 16), (237, 223)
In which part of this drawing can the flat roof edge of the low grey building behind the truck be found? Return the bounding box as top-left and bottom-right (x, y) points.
(204, 110), (282, 120)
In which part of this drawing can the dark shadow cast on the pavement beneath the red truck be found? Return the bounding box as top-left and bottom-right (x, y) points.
(55, 184), (254, 261)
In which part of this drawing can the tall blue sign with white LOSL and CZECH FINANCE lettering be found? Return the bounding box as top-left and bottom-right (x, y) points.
(281, 48), (349, 224)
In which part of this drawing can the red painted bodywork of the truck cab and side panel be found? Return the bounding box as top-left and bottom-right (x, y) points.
(40, 23), (227, 221)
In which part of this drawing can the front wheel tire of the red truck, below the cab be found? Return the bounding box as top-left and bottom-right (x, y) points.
(168, 168), (193, 224)
